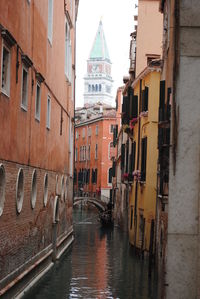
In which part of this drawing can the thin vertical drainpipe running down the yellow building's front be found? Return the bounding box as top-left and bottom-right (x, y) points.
(134, 79), (142, 249)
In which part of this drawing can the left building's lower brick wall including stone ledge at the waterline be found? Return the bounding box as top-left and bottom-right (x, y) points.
(0, 160), (73, 298)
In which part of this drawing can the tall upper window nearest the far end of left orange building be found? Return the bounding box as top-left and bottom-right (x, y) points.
(65, 22), (72, 82)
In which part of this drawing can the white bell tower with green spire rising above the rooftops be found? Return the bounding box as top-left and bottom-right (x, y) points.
(84, 21), (113, 105)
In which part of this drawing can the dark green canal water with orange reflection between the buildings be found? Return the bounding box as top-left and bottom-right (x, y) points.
(26, 208), (157, 299)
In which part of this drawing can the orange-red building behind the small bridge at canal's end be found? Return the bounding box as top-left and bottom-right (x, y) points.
(74, 105), (117, 201)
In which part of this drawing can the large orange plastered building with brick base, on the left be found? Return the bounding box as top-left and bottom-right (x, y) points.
(0, 0), (78, 298)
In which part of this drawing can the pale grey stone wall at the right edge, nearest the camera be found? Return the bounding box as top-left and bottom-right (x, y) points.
(166, 0), (200, 299)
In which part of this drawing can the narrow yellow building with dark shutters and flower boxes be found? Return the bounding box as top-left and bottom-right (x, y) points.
(129, 61), (161, 254)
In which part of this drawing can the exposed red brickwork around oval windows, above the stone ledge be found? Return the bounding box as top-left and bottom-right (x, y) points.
(0, 160), (72, 286)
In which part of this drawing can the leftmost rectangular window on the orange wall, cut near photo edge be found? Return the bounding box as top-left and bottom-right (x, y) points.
(1, 45), (10, 96)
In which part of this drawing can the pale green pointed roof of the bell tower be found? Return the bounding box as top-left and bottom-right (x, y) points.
(89, 21), (110, 61)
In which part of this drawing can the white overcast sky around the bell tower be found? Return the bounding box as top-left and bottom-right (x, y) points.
(76, 0), (137, 107)
